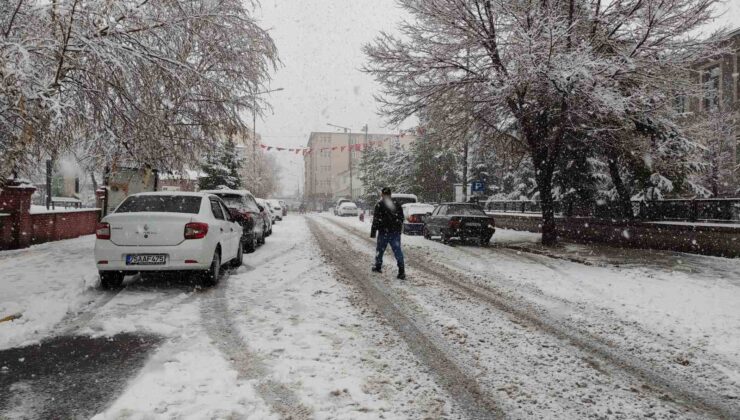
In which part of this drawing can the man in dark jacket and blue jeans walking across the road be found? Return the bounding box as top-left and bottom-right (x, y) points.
(370, 187), (406, 280)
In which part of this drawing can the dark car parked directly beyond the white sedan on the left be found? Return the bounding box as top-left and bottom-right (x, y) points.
(201, 188), (267, 253)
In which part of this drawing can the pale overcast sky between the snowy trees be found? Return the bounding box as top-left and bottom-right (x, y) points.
(257, 0), (740, 197)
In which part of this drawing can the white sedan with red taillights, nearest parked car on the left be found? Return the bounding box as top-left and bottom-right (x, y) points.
(95, 192), (243, 289)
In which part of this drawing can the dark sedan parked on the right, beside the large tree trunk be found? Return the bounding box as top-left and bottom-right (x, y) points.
(423, 203), (496, 245)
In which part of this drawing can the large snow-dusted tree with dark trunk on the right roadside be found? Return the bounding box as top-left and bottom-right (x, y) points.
(365, 0), (718, 244)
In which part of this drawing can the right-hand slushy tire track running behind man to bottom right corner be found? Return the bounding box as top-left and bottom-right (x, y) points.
(320, 218), (740, 418)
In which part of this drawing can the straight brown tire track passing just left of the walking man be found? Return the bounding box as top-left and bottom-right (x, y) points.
(308, 218), (504, 419)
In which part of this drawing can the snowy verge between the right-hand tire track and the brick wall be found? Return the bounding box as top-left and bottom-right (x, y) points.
(334, 215), (740, 374)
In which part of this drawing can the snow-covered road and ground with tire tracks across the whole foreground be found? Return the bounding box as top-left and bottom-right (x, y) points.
(0, 214), (740, 419)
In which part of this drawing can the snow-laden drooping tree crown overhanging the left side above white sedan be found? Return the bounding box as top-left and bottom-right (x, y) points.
(0, 0), (276, 184)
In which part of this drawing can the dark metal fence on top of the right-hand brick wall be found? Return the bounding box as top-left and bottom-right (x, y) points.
(485, 198), (740, 223)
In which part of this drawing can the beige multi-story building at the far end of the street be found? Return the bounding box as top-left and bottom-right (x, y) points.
(304, 132), (416, 207)
